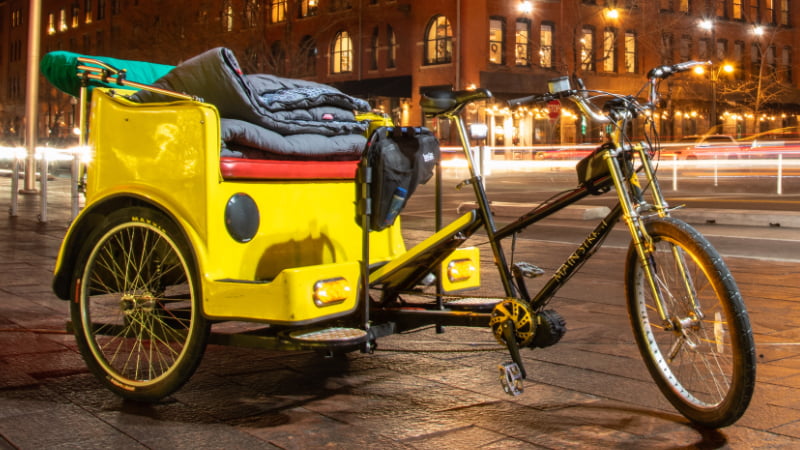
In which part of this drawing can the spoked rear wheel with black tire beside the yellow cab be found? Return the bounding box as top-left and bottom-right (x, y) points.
(70, 207), (210, 402)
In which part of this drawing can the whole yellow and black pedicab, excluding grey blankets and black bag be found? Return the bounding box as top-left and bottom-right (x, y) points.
(47, 51), (755, 427)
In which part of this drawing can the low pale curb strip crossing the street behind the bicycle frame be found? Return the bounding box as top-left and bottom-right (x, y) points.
(458, 202), (800, 228)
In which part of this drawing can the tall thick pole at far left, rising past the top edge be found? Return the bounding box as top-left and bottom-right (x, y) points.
(23, 0), (42, 193)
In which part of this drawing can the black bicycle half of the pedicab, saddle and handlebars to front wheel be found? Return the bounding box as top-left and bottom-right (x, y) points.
(416, 61), (756, 427)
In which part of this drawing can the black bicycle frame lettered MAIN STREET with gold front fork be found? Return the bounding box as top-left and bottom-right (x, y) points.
(380, 83), (690, 342)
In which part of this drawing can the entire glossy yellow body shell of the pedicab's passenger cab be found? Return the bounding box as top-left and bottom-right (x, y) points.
(64, 88), (405, 324)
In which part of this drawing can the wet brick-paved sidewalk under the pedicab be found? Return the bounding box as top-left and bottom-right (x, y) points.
(0, 179), (800, 449)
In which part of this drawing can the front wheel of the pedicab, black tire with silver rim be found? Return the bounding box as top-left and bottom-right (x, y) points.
(625, 218), (756, 428)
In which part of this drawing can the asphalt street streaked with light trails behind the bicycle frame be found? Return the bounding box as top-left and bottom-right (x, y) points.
(403, 161), (800, 261)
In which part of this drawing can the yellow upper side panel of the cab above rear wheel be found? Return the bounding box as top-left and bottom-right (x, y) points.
(86, 89), (216, 244)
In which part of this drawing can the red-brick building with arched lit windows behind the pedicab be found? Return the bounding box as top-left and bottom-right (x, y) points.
(0, 0), (800, 146)
